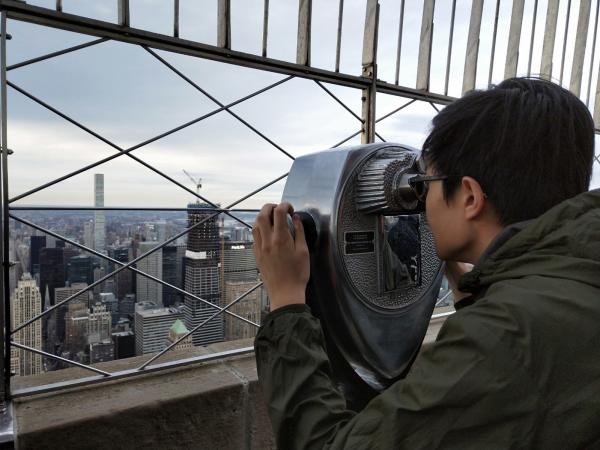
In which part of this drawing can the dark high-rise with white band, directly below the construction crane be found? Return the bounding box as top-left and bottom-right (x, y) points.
(184, 203), (223, 345)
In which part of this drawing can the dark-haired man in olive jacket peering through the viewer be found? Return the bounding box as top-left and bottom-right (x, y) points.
(253, 78), (600, 449)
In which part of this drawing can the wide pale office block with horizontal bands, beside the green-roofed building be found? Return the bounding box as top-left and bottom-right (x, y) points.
(135, 305), (183, 355)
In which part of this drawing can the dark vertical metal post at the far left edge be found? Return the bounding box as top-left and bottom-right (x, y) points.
(0, 11), (11, 400)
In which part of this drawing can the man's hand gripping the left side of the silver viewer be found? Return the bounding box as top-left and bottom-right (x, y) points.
(252, 203), (310, 311)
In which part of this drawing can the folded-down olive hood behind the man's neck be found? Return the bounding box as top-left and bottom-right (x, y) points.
(458, 189), (600, 292)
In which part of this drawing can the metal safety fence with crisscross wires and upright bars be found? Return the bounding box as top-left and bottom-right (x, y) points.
(0, 0), (600, 404)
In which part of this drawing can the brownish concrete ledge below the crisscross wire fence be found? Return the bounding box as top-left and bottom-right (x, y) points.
(13, 317), (445, 450)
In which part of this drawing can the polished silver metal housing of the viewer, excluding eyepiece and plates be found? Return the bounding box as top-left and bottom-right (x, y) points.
(283, 144), (442, 389)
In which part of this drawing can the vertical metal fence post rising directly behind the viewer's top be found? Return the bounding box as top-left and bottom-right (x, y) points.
(361, 0), (379, 144)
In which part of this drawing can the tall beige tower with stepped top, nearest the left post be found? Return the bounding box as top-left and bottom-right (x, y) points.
(10, 273), (42, 375)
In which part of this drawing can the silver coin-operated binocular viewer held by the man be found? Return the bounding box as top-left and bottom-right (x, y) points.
(282, 143), (443, 408)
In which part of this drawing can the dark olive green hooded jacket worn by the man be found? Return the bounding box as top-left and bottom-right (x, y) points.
(255, 190), (600, 449)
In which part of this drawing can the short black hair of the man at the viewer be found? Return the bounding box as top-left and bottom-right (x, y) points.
(423, 78), (594, 226)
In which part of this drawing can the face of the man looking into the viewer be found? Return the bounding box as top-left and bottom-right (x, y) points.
(425, 165), (469, 261)
